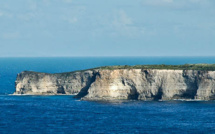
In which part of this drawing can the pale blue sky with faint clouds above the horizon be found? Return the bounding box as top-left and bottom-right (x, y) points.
(0, 0), (215, 57)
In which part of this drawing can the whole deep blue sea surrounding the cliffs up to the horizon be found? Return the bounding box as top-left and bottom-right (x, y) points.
(0, 57), (215, 134)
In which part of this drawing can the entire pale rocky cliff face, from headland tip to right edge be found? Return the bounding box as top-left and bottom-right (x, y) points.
(14, 69), (215, 100)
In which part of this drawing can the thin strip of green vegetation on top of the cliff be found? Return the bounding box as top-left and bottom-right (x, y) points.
(94, 64), (215, 71)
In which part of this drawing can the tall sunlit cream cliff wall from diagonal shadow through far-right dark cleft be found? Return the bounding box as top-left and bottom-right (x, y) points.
(84, 69), (197, 100)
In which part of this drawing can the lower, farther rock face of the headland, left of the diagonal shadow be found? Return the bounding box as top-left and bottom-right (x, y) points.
(14, 71), (94, 95)
